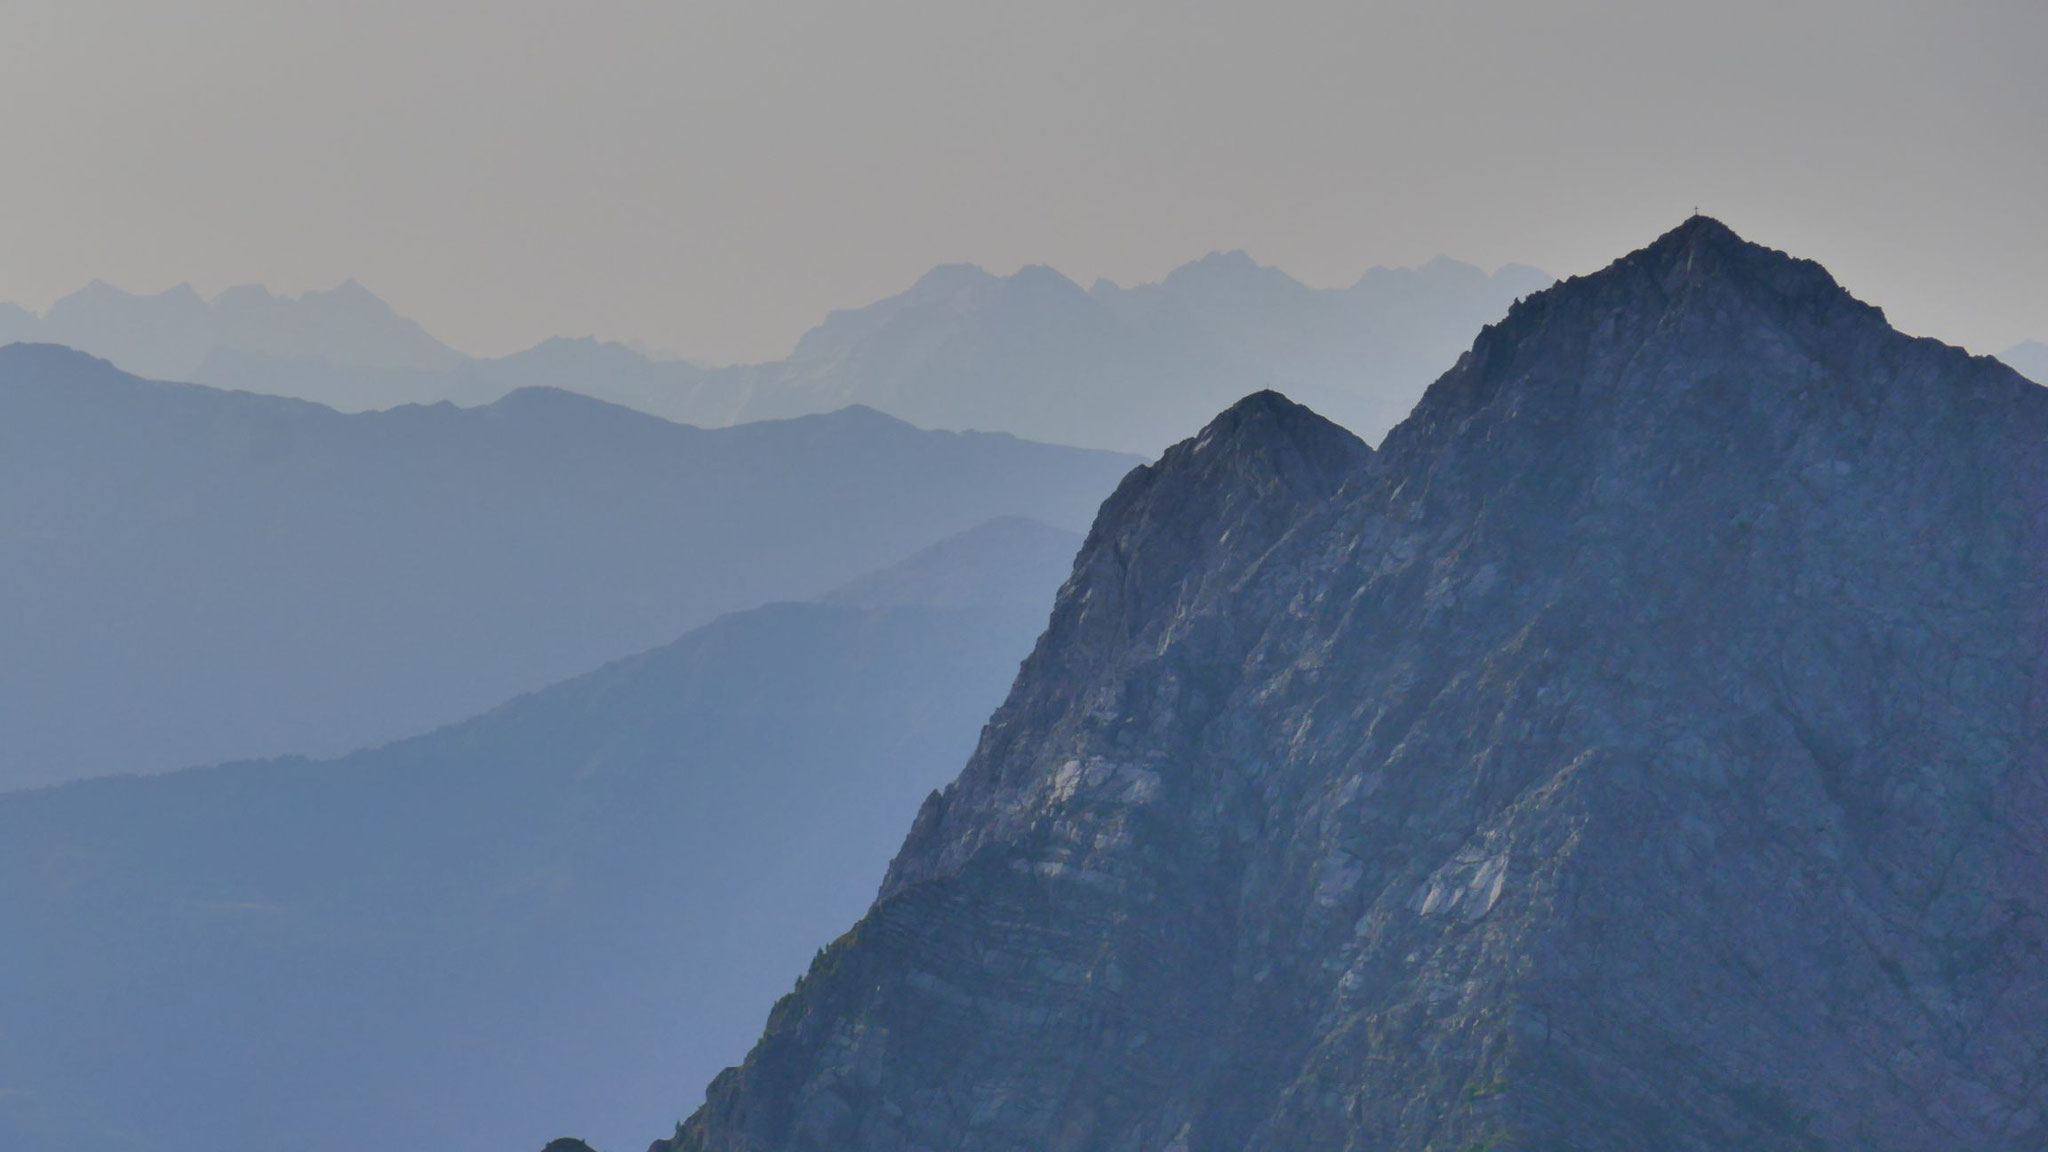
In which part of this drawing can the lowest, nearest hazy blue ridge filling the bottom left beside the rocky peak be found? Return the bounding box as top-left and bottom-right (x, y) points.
(0, 521), (1079, 1152)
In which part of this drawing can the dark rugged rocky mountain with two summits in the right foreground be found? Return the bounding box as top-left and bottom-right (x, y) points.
(655, 217), (2048, 1152)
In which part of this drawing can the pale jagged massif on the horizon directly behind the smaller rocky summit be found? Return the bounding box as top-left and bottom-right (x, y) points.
(720, 252), (1550, 453)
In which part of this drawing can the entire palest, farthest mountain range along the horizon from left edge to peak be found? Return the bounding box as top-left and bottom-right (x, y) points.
(0, 252), (1550, 455)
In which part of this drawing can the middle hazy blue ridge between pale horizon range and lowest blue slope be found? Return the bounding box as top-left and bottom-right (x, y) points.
(0, 344), (1135, 787)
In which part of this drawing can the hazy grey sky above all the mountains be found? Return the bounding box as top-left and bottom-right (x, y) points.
(0, 0), (2048, 359)
